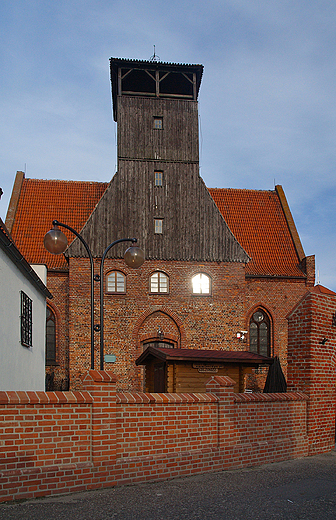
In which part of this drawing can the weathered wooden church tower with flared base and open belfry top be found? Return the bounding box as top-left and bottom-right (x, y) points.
(68, 58), (249, 262)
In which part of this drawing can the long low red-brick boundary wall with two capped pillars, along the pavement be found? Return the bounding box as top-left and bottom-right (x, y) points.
(0, 370), (308, 501)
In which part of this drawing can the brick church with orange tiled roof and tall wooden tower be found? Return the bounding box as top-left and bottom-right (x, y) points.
(6, 58), (320, 390)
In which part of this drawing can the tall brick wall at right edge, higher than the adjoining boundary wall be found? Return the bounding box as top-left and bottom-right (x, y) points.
(288, 292), (336, 454)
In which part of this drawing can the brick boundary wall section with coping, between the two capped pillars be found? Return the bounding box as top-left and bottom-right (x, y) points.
(117, 392), (218, 458)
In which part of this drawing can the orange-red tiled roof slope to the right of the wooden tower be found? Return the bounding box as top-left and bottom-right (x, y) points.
(209, 188), (304, 277)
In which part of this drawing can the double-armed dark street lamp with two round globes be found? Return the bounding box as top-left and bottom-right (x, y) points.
(43, 220), (145, 370)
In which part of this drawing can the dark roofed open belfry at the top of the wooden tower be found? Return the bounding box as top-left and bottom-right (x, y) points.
(110, 58), (203, 121)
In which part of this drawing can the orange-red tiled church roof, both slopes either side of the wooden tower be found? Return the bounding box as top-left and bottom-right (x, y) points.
(11, 178), (305, 277)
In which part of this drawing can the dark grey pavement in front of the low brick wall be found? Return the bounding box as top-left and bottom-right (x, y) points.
(0, 450), (336, 520)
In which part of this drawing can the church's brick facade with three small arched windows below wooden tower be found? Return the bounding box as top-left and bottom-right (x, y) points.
(69, 258), (307, 391)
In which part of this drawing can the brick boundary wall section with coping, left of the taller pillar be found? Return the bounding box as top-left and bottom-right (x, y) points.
(0, 392), (92, 471)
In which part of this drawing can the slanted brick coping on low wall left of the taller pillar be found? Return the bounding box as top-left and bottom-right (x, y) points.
(0, 391), (93, 405)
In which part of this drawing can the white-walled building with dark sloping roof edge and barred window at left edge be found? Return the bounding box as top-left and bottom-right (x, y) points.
(0, 219), (52, 391)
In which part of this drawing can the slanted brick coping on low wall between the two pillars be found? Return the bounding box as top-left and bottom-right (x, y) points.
(117, 392), (218, 404)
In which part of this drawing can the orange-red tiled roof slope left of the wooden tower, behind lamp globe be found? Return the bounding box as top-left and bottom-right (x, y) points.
(11, 179), (108, 269)
